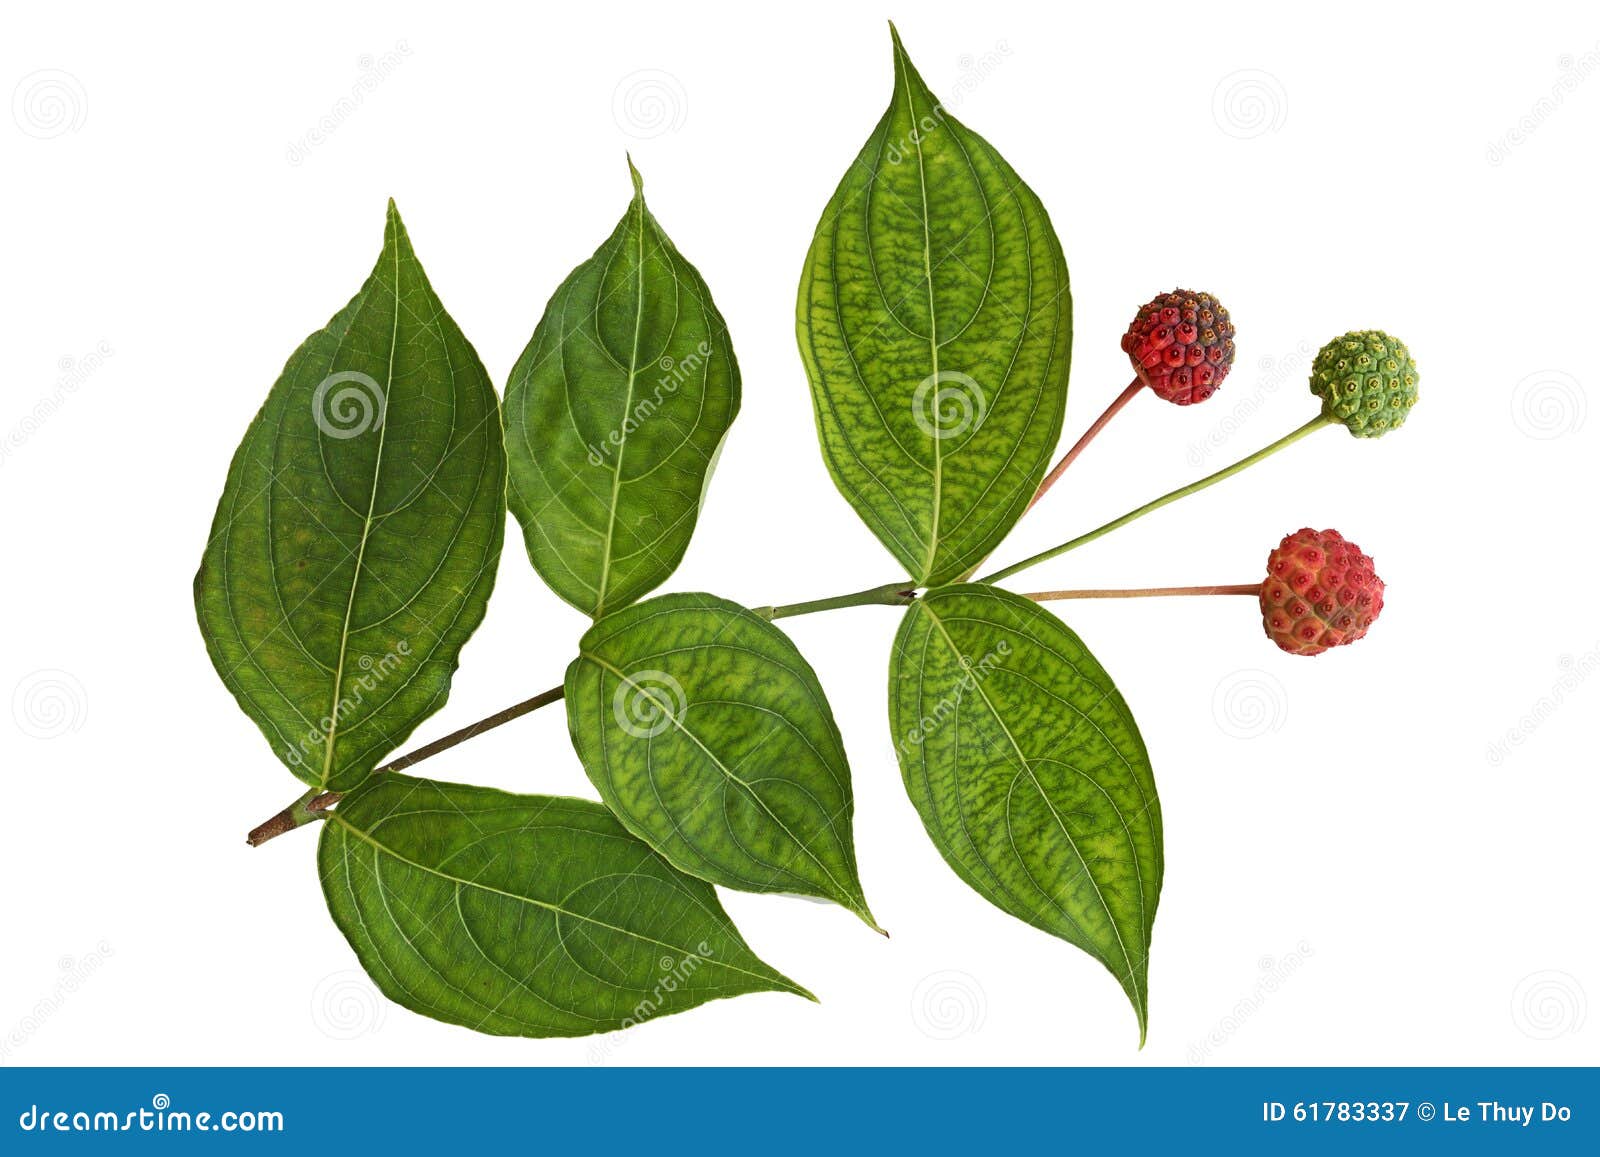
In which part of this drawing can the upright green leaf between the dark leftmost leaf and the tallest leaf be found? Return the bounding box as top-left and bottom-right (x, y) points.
(506, 162), (739, 618)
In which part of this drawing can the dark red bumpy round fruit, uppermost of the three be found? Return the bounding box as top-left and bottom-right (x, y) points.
(1122, 290), (1234, 406)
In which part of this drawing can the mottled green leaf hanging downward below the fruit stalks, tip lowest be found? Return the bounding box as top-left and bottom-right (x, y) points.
(890, 584), (1162, 1045)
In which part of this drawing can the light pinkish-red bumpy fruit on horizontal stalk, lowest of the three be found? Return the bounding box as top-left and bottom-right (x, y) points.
(1261, 530), (1384, 655)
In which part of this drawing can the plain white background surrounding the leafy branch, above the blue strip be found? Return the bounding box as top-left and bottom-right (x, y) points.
(0, 0), (1600, 1064)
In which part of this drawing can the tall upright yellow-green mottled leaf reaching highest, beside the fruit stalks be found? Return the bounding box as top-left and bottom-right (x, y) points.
(797, 27), (1072, 586)
